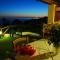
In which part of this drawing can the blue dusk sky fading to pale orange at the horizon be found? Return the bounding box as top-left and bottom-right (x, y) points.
(0, 0), (48, 16)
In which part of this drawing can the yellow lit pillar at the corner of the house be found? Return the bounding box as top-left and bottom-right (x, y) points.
(48, 4), (56, 24)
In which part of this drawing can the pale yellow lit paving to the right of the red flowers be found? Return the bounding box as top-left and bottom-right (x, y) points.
(27, 39), (60, 60)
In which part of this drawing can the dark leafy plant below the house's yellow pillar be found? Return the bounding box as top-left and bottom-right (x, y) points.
(49, 25), (60, 54)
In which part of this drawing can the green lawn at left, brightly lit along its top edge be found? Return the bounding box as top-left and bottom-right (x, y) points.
(0, 37), (15, 60)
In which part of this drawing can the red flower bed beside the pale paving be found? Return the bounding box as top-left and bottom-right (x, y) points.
(16, 45), (36, 56)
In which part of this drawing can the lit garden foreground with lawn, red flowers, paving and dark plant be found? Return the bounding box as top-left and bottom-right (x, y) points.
(0, 24), (60, 60)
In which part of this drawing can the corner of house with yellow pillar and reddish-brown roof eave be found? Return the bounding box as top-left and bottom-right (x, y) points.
(39, 0), (60, 24)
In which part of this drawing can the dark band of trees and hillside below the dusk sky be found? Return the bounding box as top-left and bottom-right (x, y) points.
(0, 17), (47, 37)
